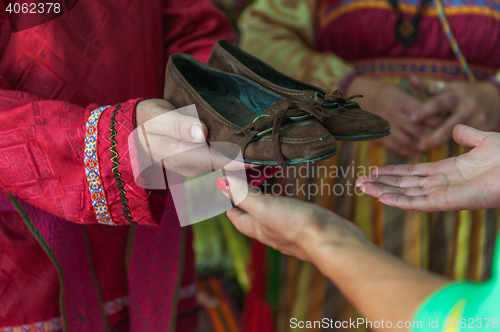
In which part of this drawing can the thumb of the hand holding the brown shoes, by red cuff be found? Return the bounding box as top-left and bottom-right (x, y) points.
(143, 108), (208, 143)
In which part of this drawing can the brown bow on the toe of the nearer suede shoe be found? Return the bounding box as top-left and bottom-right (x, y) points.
(234, 99), (330, 166)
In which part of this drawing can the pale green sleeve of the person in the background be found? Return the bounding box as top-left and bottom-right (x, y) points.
(238, 0), (354, 92)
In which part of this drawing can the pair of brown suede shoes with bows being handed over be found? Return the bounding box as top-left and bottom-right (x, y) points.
(164, 40), (390, 166)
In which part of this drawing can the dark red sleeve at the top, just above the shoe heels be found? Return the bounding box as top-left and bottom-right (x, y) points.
(164, 0), (234, 63)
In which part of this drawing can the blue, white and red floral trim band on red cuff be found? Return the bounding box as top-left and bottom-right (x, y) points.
(84, 106), (116, 225)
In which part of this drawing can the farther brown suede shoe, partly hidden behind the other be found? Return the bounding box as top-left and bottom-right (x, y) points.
(207, 40), (391, 141)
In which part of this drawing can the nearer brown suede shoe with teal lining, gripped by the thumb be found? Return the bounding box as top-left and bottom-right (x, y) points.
(164, 54), (338, 166)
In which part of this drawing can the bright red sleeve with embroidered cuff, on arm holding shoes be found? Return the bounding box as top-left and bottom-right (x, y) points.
(0, 88), (162, 225)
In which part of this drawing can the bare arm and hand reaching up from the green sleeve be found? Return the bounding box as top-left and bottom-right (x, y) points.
(218, 178), (449, 330)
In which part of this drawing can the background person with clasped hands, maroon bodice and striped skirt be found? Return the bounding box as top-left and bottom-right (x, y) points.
(239, 0), (500, 331)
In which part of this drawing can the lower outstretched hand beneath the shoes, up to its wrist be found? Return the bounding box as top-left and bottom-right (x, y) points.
(217, 177), (368, 261)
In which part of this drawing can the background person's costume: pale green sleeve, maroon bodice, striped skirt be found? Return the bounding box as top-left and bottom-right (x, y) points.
(239, 0), (500, 332)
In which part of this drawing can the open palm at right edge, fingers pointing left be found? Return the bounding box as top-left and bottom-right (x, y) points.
(356, 125), (500, 212)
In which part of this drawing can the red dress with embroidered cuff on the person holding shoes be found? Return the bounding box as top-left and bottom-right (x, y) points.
(0, 0), (232, 332)
